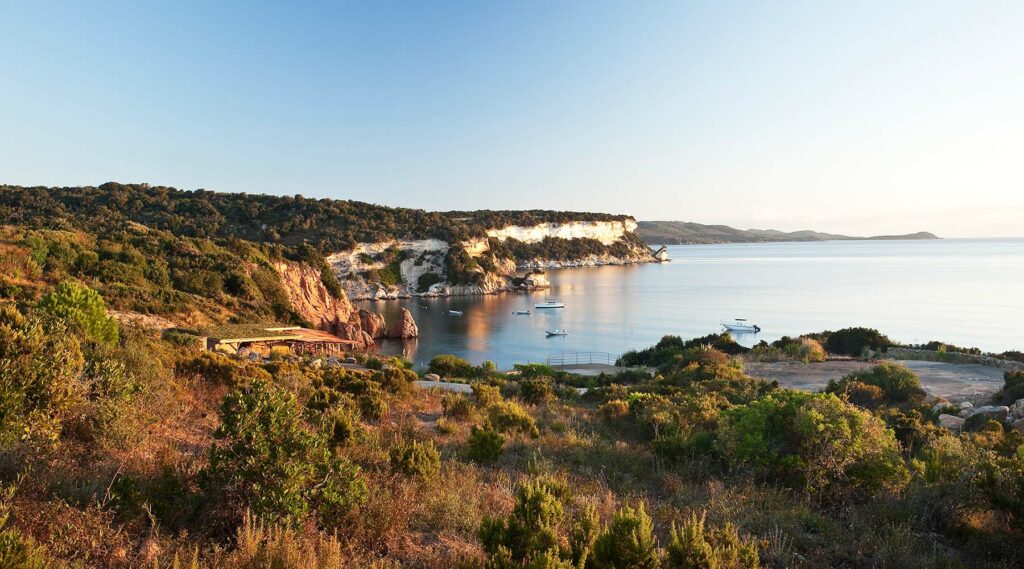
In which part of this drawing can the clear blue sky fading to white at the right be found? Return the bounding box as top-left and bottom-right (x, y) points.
(0, 0), (1024, 237)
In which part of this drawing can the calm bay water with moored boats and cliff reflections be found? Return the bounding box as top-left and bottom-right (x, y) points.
(364, 239), (1024, 368)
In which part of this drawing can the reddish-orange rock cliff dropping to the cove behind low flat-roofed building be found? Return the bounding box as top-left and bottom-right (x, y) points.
(273, 261), (416, 348)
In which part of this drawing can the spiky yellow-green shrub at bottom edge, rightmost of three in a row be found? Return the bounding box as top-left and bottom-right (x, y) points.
(665, 512), (761, 569)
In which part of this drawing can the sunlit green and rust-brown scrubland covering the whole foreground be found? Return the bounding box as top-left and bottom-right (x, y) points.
(0, 274), (1024, 569)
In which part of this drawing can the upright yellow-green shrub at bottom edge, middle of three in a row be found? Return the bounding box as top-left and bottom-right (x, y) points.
(593, 501), (659, 569)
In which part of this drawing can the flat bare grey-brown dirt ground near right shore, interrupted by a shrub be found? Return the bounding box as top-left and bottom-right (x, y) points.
(745, 360), (1002, 402)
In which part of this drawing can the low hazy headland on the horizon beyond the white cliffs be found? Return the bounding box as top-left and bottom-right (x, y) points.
(636, 221), (939, 245)
